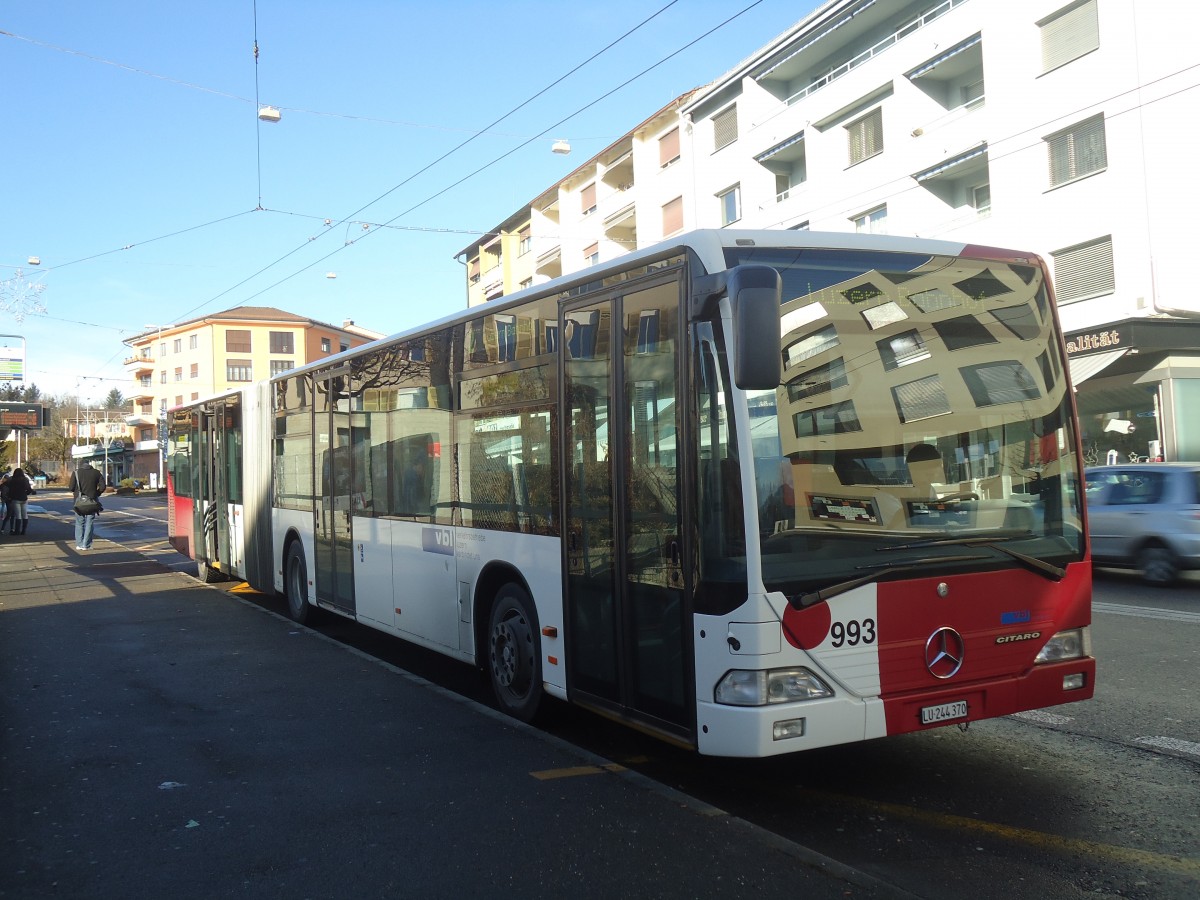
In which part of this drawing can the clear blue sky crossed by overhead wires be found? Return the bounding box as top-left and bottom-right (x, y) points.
(0, 0), (818, 402)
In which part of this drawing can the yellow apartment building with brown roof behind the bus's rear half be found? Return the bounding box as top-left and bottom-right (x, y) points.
(114, 306), (383, 478)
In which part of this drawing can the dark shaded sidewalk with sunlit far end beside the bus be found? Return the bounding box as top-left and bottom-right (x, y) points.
(0, 515), (895, 900)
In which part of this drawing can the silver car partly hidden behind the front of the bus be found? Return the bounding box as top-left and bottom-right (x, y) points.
(1085, 462), (1200, 584)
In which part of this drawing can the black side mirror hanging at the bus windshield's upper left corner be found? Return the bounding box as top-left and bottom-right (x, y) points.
(726, 265), (784, 390)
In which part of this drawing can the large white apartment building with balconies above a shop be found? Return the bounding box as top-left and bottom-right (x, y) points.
(456, 0), (1200, 461)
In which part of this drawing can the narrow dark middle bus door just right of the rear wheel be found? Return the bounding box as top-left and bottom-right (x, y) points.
(313, 372), (354, 614)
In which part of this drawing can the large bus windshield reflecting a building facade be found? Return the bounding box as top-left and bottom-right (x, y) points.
(697, 247), (1084, 609)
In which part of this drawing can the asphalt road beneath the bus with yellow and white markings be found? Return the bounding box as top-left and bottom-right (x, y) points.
(35, 496), (1200, 900)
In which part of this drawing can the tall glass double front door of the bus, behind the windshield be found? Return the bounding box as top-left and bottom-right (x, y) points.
(559, 280), (692, 740)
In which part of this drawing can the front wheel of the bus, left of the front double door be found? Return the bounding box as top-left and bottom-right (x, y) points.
(487, 582), (542, 722)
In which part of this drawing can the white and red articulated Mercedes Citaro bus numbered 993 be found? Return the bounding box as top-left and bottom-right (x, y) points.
(168, 230), (1096, 756)
